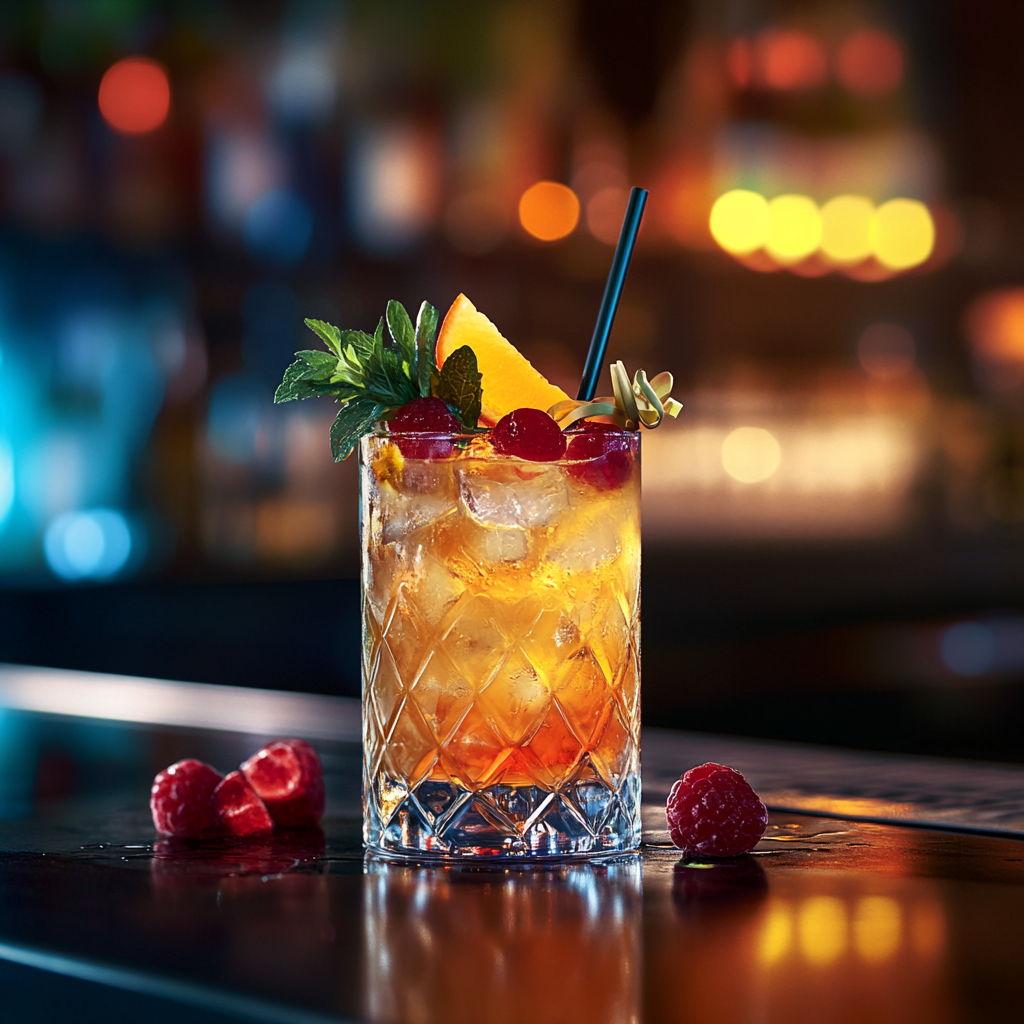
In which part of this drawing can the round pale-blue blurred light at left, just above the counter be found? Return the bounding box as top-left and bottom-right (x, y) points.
(43, 509), (132, 580)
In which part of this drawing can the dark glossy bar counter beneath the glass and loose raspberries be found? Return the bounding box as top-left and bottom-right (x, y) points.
(0, 666), (1024, 1024)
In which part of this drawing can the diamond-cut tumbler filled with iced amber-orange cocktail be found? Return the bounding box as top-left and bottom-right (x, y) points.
(359, 431), (640, 859)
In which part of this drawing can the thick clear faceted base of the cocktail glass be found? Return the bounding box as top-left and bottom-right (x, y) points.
(364, 774), (640, 860)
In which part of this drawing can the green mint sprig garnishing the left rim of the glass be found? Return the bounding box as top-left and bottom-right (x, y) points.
(273, 299), (482, 462)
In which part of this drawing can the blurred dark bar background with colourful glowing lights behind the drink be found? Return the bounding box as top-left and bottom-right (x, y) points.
(0, 0), (1024, 760)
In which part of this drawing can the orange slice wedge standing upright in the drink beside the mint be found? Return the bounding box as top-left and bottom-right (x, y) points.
(435, 295), (568, 426)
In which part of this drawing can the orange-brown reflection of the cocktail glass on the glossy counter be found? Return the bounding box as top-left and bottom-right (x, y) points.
(364, 857), (643, 1024)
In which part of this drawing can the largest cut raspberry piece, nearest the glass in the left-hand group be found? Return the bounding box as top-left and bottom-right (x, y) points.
(242, 739), (324, 826)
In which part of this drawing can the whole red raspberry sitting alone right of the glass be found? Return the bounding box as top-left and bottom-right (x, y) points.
(666, 763), (768, 857)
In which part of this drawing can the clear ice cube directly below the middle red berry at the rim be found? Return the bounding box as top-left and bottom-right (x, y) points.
(459, 466), (569, 528)
